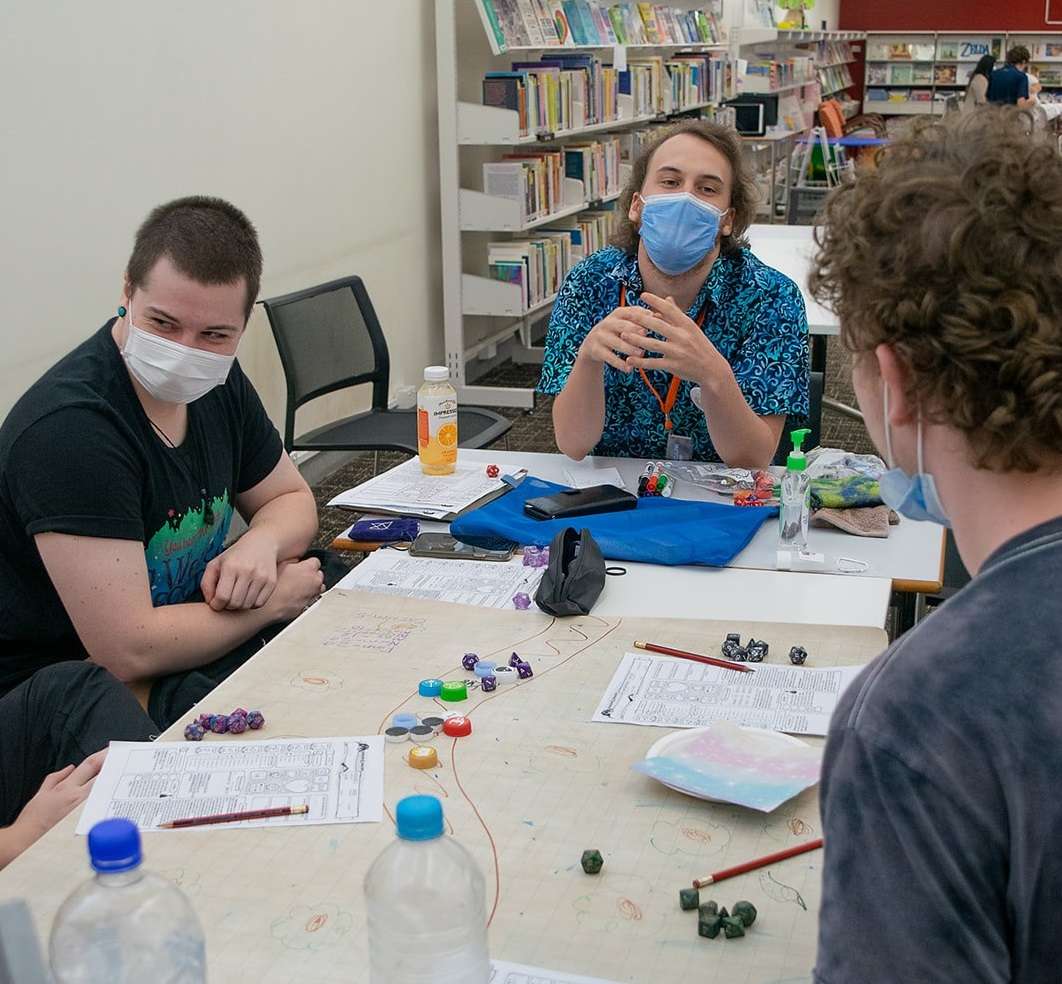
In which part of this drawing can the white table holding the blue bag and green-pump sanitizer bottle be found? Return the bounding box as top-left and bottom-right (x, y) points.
(461, 449), (944, 593)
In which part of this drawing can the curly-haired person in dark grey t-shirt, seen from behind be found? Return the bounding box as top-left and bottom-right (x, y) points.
(810, 107), (1062, 984)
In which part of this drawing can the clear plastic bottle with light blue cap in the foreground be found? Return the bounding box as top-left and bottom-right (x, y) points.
(365, 796), (491, 984)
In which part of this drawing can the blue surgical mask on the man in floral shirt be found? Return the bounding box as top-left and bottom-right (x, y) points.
(638, 191), (726, 277)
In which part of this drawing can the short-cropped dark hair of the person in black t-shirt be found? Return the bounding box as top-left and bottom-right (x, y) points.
(125, 195), (262, 317)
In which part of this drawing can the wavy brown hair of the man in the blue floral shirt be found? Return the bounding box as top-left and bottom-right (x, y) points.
(611, 120), (757, 256)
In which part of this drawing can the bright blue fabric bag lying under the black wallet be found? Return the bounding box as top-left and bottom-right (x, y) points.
(450, 476), (778, 567)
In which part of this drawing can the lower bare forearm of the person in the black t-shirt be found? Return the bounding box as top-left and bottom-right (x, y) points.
(89, 602), (279, 684)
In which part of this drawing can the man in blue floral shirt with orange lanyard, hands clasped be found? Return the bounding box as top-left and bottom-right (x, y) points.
(538, 120), (808, 468)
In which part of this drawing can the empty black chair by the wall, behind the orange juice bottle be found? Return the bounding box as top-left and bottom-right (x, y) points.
(262, 277), (512, 462)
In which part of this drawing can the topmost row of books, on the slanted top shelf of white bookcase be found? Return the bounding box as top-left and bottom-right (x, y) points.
(476, 0), (724, 54)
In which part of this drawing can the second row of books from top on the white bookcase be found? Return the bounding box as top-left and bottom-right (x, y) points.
(482, 52), (732, 136)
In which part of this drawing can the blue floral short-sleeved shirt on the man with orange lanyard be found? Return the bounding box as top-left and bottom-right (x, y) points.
(538, 246), (809, 461)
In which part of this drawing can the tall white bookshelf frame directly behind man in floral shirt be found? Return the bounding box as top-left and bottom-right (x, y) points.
(435, 0), (731, 409)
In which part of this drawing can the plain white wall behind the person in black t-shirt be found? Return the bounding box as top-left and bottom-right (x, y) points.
(0, 0), (443, 427)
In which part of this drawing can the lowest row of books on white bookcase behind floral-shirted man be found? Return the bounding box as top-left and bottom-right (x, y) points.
(487, 206), (618, 311)
